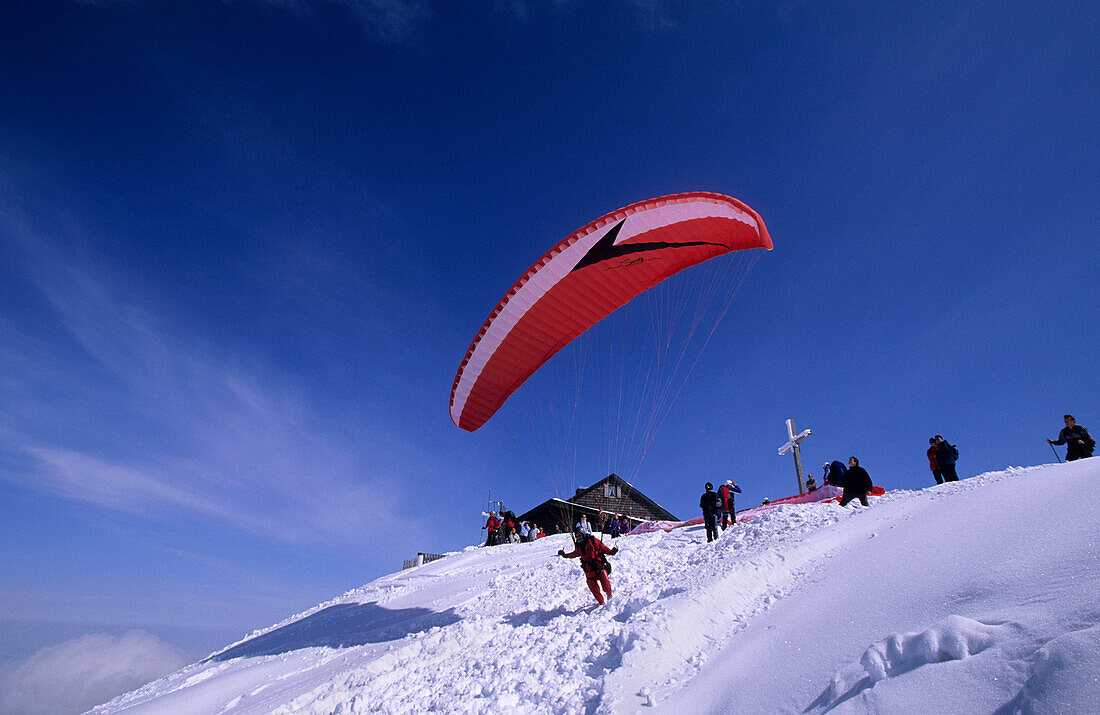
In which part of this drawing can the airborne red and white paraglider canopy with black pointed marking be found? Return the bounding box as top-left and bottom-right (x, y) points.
(451, 191), (772, 431)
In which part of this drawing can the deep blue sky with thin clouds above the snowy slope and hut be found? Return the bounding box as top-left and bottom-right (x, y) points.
(0, 0), (1100, 653)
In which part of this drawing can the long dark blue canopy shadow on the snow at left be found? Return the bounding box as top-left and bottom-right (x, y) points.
(207, 603), (461, 661)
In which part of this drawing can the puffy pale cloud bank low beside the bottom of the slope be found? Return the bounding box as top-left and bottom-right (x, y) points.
(0, 630), (188, 715)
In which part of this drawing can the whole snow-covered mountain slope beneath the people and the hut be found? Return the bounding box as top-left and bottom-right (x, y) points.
(96, 459), (1100, 713)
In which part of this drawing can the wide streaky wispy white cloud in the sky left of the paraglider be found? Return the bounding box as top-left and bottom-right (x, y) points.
(0, 207), (409, 542)
